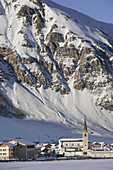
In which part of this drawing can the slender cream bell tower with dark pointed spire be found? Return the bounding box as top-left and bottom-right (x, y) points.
(83, 118), (88, 154)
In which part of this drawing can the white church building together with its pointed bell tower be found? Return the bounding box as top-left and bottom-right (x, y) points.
(59, 118), (88, 156)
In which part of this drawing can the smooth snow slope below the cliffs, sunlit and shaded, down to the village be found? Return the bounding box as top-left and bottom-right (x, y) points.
(0, 83), (113, 143)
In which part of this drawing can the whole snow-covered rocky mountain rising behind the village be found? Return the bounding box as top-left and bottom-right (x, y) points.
(0, 0), (113, 142)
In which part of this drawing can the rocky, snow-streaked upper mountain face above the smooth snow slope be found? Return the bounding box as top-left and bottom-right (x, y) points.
(0, 0), (113, 123)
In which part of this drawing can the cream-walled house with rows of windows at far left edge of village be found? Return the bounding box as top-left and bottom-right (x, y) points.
(0, 142), (16, 160)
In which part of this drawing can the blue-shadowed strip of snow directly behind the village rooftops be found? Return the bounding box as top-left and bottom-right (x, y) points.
(0, 117), (113, 144)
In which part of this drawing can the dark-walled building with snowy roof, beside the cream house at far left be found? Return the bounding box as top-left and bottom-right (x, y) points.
(7, 139), (35, 160)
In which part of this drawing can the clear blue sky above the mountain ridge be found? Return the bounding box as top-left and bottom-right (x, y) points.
(52, 0), (113, 23)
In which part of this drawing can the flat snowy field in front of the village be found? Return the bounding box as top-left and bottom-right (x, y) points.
(0, 159), (113, 170)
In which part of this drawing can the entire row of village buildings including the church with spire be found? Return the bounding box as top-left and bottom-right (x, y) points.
(0, 119), (113, 160)
